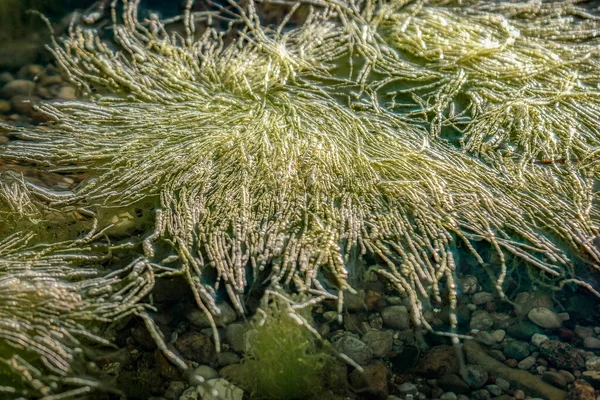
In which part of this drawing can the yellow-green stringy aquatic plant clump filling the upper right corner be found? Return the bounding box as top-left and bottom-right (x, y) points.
(322, 0), (600, 170)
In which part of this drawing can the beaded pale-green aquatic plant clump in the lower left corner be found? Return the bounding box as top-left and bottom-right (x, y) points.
(0, 233), (154, 399)
